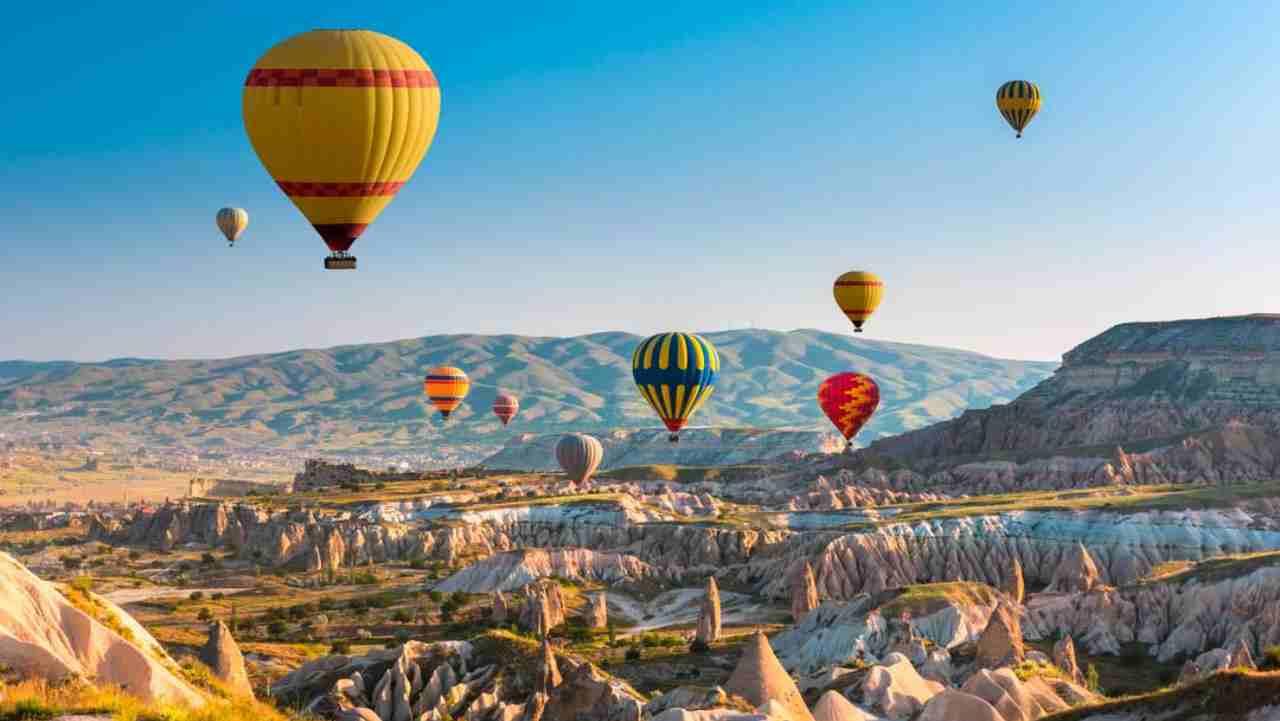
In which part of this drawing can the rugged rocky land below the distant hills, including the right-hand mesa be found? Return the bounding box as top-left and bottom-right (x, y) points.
(0, 316), (1280, 721)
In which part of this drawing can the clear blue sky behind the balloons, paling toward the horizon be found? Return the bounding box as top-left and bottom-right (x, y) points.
(0, 0), (1280, 360)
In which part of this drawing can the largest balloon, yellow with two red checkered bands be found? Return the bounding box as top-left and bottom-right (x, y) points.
(243, 29), (440, 269)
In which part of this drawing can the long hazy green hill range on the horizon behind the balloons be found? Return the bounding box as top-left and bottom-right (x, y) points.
(0, 329), (1055, 451)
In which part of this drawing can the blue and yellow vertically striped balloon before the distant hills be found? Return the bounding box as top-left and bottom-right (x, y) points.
(631, 333), (719, 443)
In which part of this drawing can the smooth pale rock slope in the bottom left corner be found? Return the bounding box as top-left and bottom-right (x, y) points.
(0, 553), (205, 707)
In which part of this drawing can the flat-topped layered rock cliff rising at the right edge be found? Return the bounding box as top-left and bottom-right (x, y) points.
(863, 315), (1280, 491)
